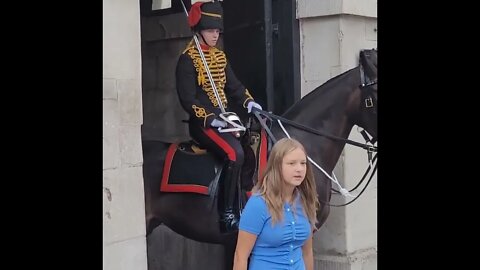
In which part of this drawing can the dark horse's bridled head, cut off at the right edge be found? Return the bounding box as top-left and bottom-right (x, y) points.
(358, 49), (378, 139)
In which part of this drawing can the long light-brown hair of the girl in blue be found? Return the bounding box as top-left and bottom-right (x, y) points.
(252, 138), (320, 227)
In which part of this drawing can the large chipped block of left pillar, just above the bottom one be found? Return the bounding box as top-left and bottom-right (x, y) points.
(103, 167), (145, 245)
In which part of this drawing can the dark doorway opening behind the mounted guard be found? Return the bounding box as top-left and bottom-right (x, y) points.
(140, 0), (300, 142)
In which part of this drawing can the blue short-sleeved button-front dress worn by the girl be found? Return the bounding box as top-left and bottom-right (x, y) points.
(239, 194), (312, 270)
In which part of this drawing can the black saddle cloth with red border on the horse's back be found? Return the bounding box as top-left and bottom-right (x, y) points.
(160, 130), (267, 195)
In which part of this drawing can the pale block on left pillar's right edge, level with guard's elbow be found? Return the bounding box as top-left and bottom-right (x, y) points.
(117, 80), (143, 125)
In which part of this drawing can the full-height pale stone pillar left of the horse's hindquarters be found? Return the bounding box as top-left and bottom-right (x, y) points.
(101, 0), (147, 270)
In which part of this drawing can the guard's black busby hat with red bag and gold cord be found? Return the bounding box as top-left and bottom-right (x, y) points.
(188, 1), (223, 32)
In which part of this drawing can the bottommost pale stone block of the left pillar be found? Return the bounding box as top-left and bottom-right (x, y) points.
(103, 234), (147, 270)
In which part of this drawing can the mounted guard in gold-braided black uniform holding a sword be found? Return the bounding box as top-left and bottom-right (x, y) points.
(176, 1), (262, 233)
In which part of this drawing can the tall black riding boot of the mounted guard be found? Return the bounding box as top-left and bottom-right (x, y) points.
(220, 162), (240, 233)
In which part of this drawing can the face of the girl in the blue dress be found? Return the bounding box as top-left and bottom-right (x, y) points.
(282, 148), (307, 187)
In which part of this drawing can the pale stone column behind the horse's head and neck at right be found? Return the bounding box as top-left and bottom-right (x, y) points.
(297, 0), (377, 270)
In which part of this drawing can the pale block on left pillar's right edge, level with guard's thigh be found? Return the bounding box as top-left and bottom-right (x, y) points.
(119, 126), (143, 167)
